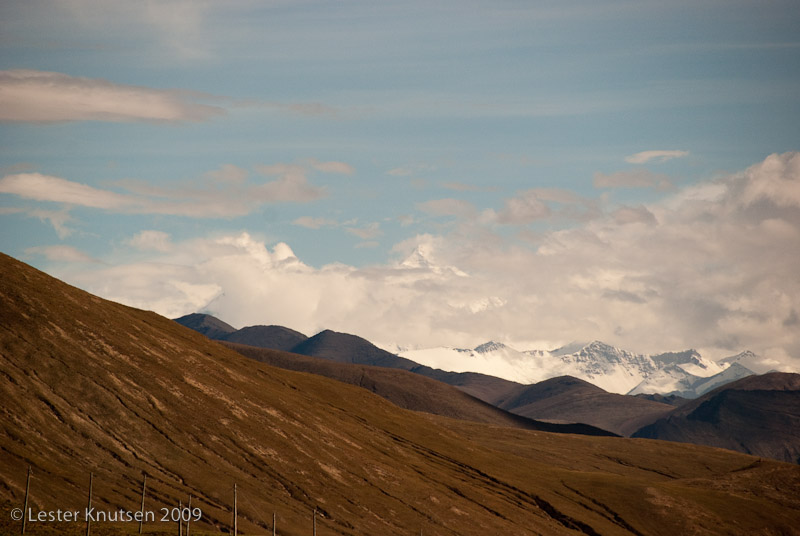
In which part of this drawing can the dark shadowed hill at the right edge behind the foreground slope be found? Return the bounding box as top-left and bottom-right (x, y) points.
(634, 372), (800, 463)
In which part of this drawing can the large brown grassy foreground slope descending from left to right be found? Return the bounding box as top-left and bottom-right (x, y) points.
(0, 252), (800, 536)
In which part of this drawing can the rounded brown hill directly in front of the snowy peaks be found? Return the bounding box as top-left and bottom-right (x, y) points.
(495, 376), (674, 435)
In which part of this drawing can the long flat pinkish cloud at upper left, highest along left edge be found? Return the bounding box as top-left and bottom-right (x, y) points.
(0, 69), (224, 122)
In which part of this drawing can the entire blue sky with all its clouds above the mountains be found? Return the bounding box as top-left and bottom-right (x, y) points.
(0, 0), (800, 364)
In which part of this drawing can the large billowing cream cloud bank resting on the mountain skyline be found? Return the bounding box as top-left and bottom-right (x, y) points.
(43, 153), (800, 366)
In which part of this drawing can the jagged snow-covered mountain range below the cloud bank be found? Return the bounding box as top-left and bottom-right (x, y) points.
(398, 341), (764, 398)
